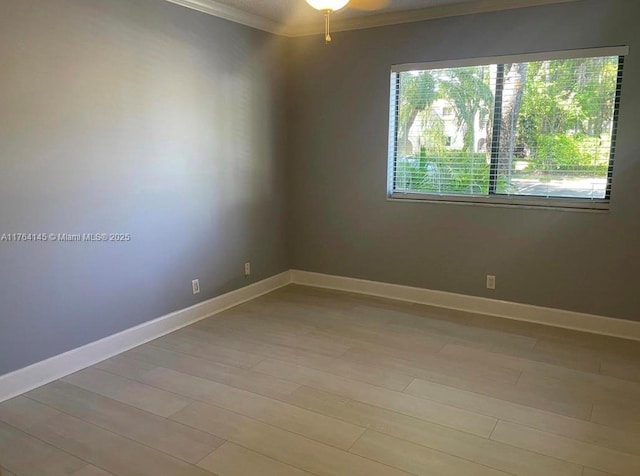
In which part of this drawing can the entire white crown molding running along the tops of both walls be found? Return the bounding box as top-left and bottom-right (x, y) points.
(166, 0), (580, 37)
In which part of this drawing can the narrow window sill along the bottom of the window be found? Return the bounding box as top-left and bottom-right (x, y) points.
(388, 192), (610, 213)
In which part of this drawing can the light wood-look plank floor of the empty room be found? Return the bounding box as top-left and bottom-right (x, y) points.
(0, 286), (640, 476)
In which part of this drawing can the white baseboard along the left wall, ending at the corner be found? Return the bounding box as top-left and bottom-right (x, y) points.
(0, 271), (291, 402)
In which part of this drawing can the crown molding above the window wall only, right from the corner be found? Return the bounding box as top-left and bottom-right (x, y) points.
(281, 0), (580, 37)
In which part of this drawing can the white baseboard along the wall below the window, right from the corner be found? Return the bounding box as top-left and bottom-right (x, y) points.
(291, 270), (640, 341)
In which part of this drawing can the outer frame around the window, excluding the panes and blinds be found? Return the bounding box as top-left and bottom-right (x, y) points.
(387, 46), (629, 211)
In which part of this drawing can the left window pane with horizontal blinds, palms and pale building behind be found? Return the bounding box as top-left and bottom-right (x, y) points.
(393, 66), (496, 195)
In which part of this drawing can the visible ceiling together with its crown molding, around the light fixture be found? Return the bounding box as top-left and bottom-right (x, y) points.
(168, 0), (577, 36)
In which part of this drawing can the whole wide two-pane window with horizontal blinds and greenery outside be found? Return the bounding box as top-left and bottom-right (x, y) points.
(389, 47), (628, 208)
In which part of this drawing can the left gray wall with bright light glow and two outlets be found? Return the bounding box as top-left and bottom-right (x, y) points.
(0, 0), (289, 375)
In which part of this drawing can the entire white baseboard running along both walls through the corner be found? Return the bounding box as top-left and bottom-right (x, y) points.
(0, 270), (640, 402)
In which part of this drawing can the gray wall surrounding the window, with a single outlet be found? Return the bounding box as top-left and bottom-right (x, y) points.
(289, 0), (640, 320)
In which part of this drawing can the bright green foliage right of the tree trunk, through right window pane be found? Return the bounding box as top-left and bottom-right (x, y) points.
(518, 57), (618, 175)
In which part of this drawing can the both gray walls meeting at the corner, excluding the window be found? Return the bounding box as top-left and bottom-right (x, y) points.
(0, 0), (640, 374)
